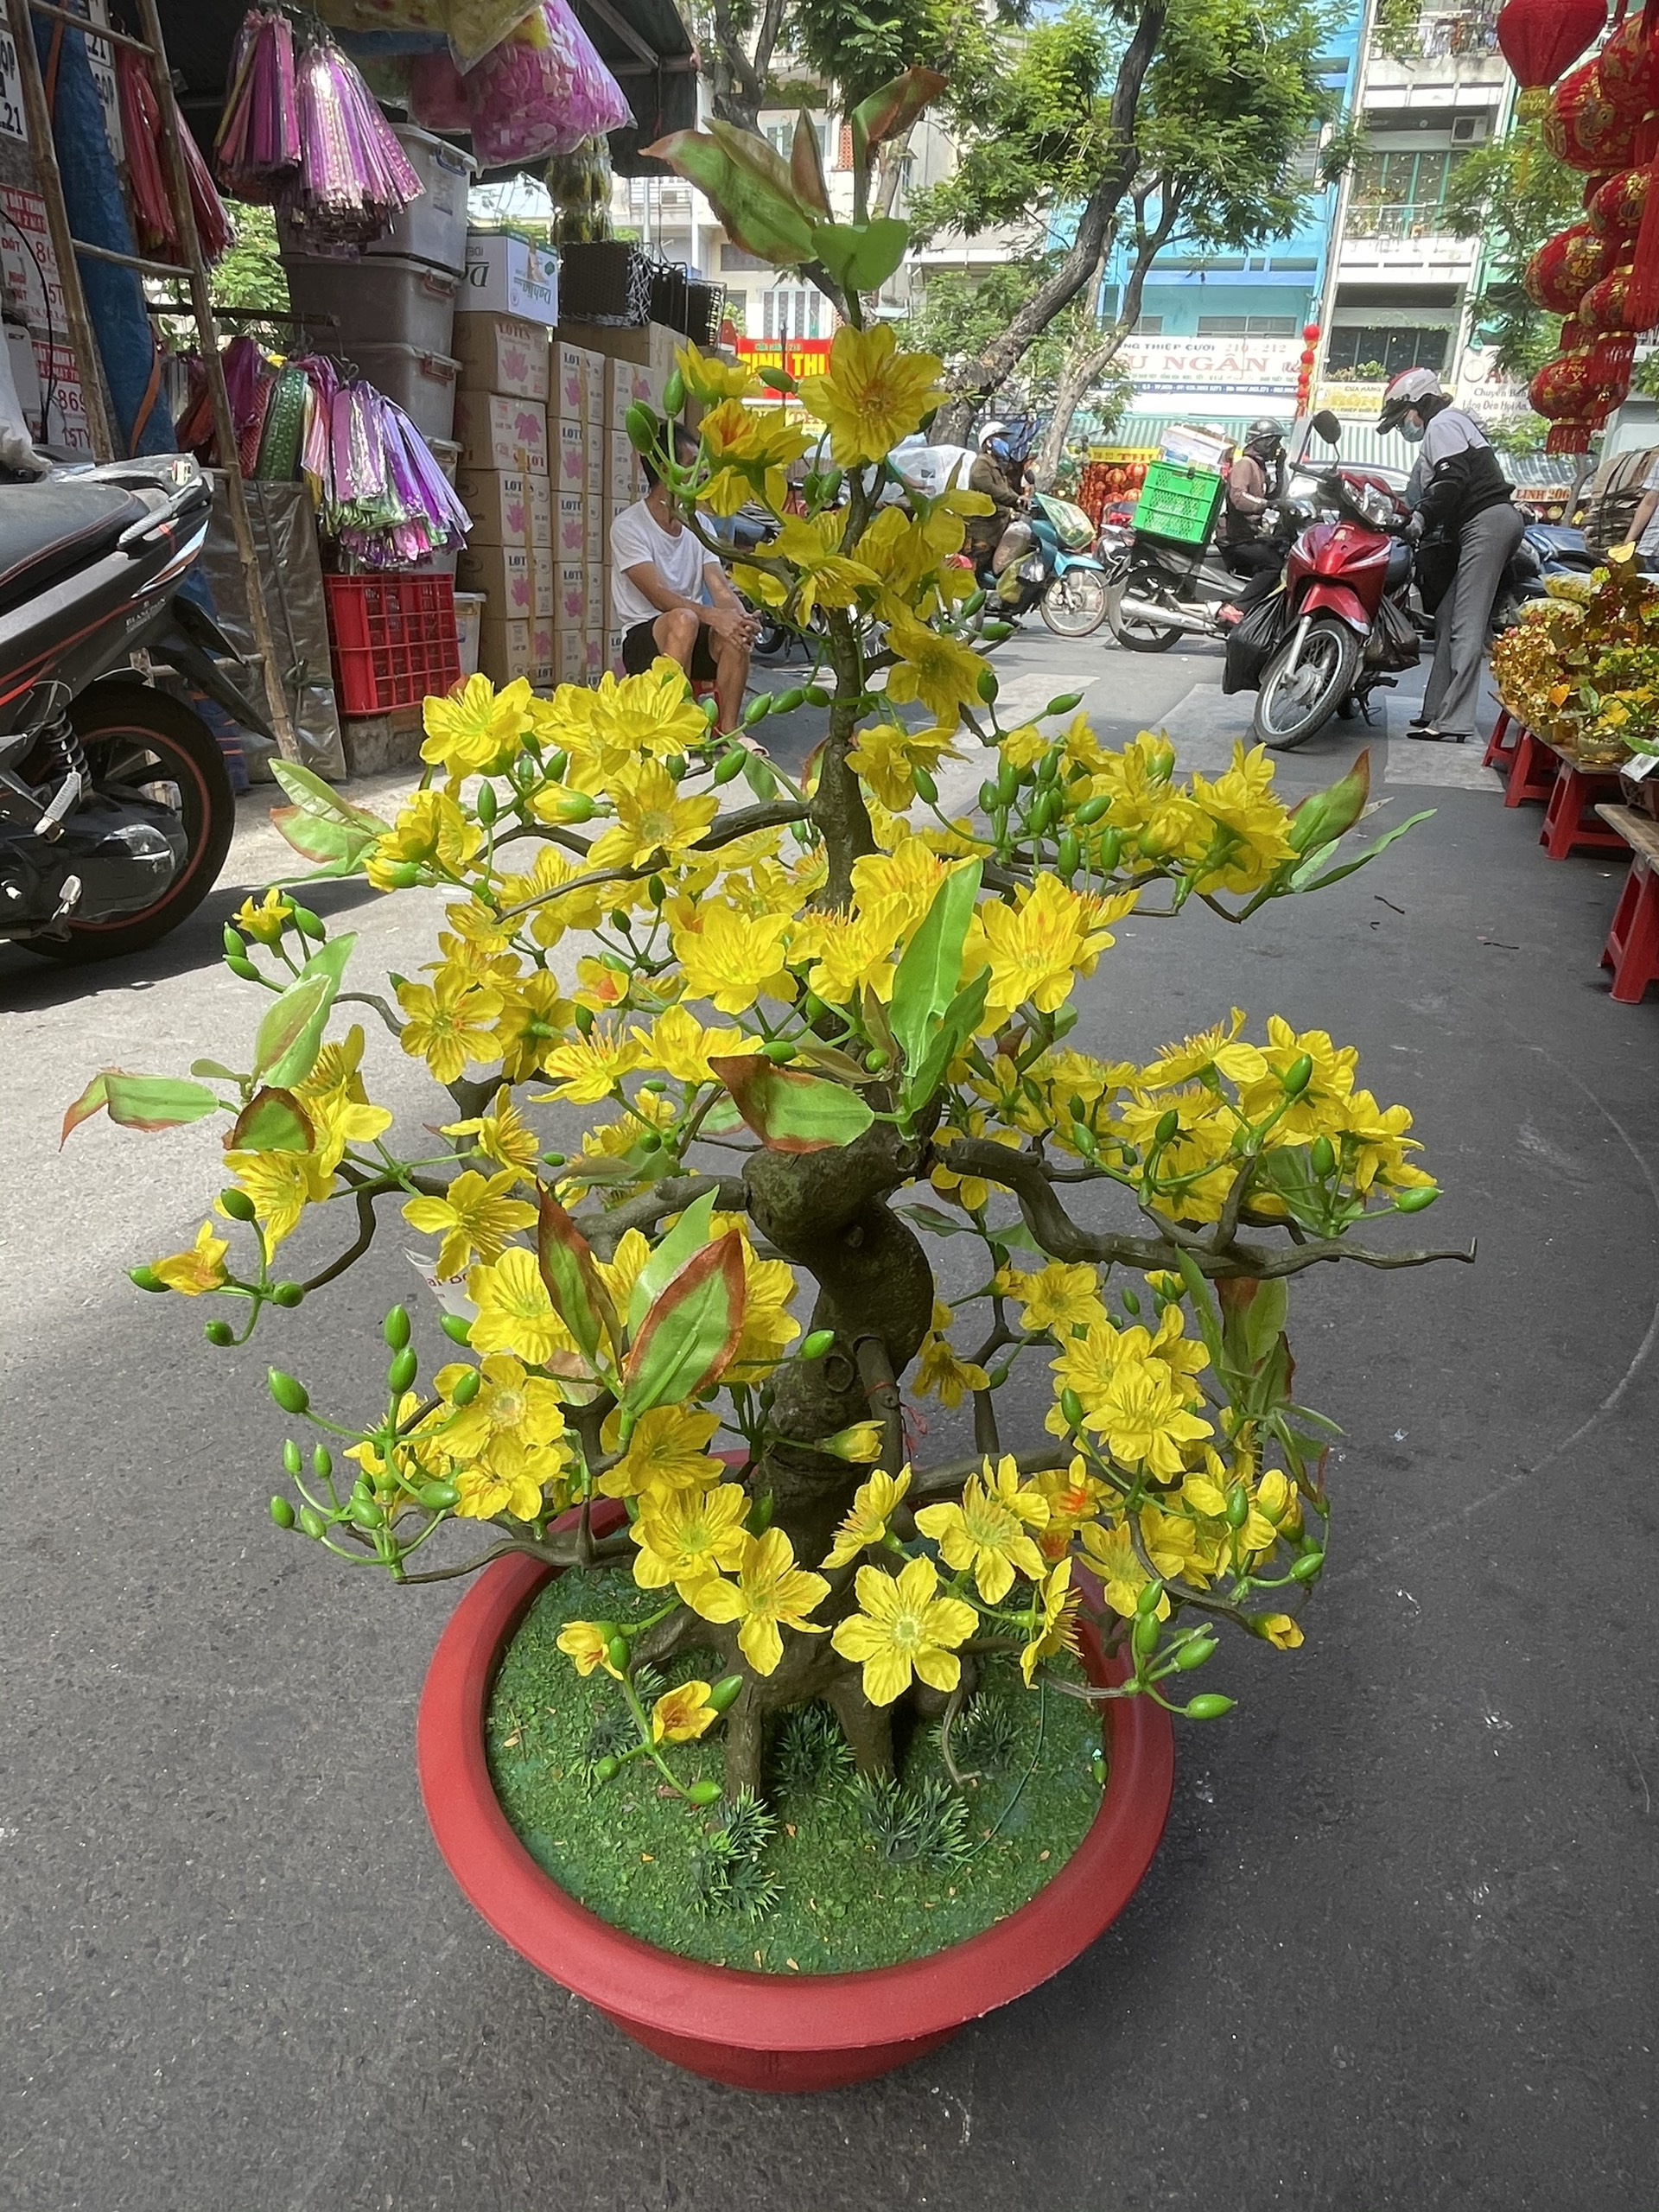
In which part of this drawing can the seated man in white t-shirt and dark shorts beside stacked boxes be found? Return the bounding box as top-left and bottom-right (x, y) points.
(611, 427), (757, 732)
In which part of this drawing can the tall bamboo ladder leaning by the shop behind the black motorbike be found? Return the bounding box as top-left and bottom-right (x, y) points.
(7, 0), (299, 761)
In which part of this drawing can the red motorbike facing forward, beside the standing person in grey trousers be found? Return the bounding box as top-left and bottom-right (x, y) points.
(1239, 469), (1422, 752)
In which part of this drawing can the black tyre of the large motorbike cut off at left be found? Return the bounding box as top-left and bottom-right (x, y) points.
(20, 683), (237, 963)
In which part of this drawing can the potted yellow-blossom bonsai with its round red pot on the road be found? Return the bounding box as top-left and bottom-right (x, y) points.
(78, 86), (1478, 2088)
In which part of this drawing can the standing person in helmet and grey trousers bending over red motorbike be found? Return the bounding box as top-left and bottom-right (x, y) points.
(1376, 370), (1524, 746)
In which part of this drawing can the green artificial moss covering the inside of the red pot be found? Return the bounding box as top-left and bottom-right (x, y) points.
(486, 1571), (1103, 1974)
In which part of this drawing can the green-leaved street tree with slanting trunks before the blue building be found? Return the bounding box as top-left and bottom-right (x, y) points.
(916, 0), (1340, 474)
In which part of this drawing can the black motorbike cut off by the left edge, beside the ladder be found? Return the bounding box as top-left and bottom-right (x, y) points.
(0, 454), (253, 960)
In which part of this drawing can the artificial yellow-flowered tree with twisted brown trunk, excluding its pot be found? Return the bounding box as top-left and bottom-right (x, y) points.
(84, 84), (1478, 1802)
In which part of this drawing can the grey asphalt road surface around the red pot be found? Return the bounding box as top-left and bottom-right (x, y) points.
(0, 635), (1659, 2212)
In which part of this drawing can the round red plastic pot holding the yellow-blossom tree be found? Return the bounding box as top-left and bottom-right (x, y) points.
(416, 1557), (1174, 2090)
